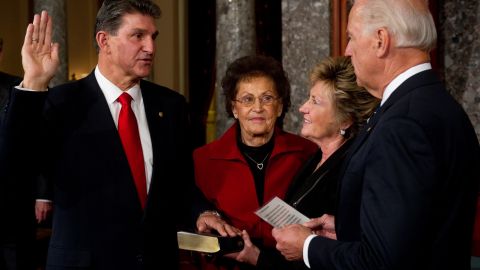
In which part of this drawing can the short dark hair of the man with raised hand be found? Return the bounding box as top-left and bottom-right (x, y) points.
(94, 0), (161, 51)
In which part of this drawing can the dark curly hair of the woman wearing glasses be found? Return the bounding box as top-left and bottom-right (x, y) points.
(222, 55), (290, 120)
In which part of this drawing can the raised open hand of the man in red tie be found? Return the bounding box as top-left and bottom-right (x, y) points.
(22, 11), (59, 91)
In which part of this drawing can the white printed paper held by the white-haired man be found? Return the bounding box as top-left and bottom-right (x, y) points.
(255, 197), (310, 228)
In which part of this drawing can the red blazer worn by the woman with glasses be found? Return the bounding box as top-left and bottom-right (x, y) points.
(193, 124), (318, 247)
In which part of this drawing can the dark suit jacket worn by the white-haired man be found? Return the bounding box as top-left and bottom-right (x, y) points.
(308, 71), (480, 270)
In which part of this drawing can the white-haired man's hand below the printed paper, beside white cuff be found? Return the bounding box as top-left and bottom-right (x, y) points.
(272, 224), (312, 261)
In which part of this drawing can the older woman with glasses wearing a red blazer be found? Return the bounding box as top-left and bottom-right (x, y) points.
(194, 56), (317, 269)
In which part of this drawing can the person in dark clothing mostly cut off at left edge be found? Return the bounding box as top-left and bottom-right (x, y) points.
(0, 38), (52, 270)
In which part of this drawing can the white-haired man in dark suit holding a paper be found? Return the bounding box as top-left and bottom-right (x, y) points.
(273, 0), (480, 270)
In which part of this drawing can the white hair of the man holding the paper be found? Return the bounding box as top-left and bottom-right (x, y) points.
(358, 0), (437, 52)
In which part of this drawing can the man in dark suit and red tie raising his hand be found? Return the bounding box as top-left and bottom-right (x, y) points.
(0, 0), (195, 270)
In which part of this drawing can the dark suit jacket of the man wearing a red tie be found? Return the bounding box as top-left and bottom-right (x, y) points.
(0, 73), (193, 270)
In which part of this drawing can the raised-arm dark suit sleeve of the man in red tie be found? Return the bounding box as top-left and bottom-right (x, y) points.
(0, 90), (46, 238)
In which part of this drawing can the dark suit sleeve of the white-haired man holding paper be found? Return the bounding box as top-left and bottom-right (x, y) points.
(308, 118), (438, 270)
